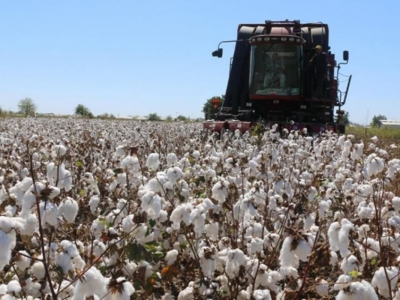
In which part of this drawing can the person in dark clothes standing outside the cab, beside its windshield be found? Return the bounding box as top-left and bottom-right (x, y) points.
(309, 45), (331, 98)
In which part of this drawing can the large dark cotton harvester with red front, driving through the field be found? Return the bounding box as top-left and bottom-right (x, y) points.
(203, 21), (351, 134)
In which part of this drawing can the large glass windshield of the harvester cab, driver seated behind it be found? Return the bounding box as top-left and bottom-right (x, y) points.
(250, 43), (302, 96)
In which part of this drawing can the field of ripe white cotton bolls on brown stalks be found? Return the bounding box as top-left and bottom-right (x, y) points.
(0, 118), (400, 300)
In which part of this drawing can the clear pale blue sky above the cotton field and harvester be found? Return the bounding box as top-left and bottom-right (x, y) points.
(0, 0), (400, 124)
